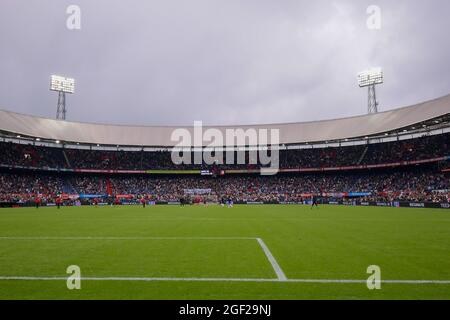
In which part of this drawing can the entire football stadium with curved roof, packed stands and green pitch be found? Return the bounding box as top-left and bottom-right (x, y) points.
(0, 96), (450, 299)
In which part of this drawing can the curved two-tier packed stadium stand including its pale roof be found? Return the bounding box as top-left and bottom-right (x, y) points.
(0, 96), (450, 208)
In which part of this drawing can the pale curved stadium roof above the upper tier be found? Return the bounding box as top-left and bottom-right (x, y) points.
(0, 95), (450, 147)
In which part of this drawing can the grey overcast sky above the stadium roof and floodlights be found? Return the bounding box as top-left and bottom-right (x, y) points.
(0, 0), (450, 125)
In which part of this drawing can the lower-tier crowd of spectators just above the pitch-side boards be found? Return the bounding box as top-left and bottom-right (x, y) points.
(0, 169), (450, 202)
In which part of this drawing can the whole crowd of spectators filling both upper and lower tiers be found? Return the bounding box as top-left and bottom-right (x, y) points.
(0, 134), (450, 202)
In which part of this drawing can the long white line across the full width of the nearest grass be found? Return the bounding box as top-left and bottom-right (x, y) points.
(0, 276), (450, 285)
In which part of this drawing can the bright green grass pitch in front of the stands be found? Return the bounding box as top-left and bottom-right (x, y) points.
(0, 205), (450, 299)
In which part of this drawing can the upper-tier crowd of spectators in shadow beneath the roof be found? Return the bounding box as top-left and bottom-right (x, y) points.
(0, 133), (450, 170)
